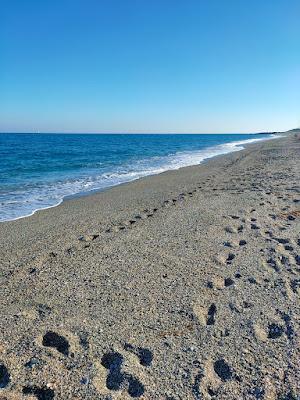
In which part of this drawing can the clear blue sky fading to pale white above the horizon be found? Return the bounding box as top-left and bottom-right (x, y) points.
(0, 0), (300, 133)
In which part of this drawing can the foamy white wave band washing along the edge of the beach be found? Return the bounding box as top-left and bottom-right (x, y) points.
(0, 135), (276, 222)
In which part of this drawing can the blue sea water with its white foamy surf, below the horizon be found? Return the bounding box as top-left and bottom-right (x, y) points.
(0, 133), (270, 221)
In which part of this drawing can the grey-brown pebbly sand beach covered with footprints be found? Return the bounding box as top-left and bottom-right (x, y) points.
(0, 133), (300, 400)
